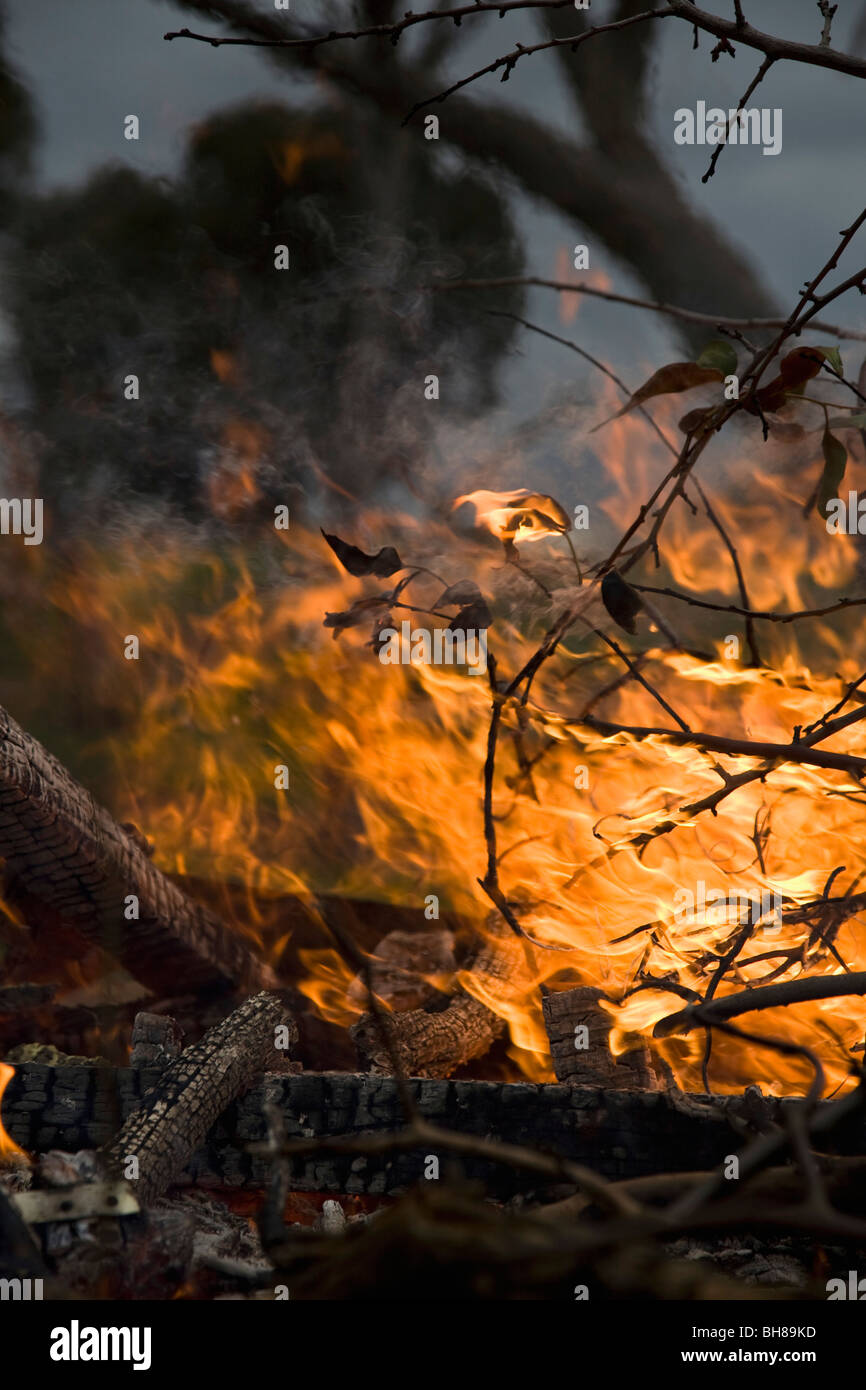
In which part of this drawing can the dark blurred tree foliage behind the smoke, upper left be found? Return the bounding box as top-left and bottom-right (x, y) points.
(7, 103), (521, 521)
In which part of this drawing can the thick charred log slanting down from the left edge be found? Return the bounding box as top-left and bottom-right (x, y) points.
(0, 708), (275, 991)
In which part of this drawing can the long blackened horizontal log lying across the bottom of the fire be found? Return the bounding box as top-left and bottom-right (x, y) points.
(10, 1065), (866, 1197)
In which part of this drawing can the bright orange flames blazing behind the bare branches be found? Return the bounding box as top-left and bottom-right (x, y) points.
(1, 372), (866, 1094)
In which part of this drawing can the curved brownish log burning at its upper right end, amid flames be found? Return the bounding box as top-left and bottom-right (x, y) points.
(349, 913), (524, 1077)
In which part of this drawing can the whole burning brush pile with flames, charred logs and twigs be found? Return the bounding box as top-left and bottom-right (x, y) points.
(6, 214), (866, 1298)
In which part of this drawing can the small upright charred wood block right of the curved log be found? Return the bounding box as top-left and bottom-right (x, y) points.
(542, 986), (659, 1091)
